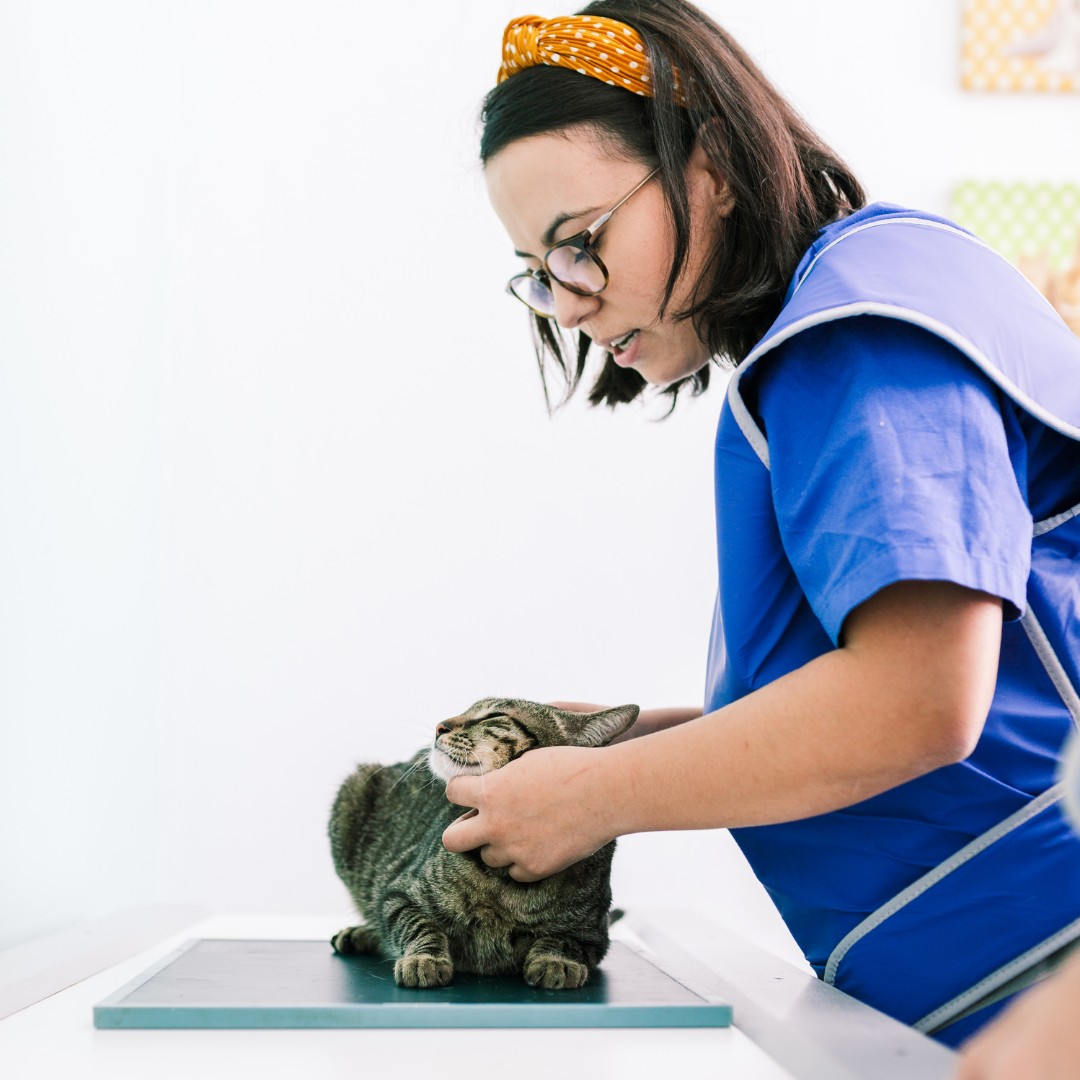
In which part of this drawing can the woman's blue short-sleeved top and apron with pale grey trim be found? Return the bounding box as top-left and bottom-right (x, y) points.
(705, 204), (1080, 1044)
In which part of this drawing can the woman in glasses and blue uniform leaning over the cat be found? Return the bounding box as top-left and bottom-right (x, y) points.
(444, 0), (1080, 1044)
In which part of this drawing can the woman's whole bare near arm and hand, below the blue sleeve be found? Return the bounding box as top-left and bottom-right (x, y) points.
(444, 581), (1001, 881)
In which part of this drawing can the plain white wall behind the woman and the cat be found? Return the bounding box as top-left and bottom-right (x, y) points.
(0, 0), (1080, 963)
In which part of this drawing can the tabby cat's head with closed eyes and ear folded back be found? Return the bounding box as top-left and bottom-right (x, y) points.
(428, 698), (638, 781)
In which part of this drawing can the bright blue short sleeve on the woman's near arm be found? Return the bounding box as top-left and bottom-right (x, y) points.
(752, 316), (1031, 644)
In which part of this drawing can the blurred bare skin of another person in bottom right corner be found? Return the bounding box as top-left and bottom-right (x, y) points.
(956, 956), (1080, 1080)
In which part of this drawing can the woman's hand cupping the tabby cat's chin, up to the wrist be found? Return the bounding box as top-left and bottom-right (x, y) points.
(443, 746), (618, 881)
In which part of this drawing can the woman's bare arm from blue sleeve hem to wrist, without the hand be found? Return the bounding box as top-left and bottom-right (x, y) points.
(594, 583), (1001, 835)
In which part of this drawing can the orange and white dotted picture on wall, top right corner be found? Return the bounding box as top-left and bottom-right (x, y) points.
(961, 0), (1080, 92)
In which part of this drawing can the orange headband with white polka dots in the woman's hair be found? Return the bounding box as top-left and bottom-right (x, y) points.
(498, 15), (681, 104)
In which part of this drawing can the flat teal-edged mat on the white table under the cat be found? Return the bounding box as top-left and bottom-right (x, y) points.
(94, 939), (731, 1028)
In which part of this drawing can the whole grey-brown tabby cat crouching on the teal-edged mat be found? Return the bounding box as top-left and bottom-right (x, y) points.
(329, 698), (638, 989)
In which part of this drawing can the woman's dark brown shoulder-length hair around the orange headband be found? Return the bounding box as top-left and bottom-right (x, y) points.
(481, 0), (865, 408)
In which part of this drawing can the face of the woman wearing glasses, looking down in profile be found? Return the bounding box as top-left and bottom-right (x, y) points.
(485, 127), (728, 386)
